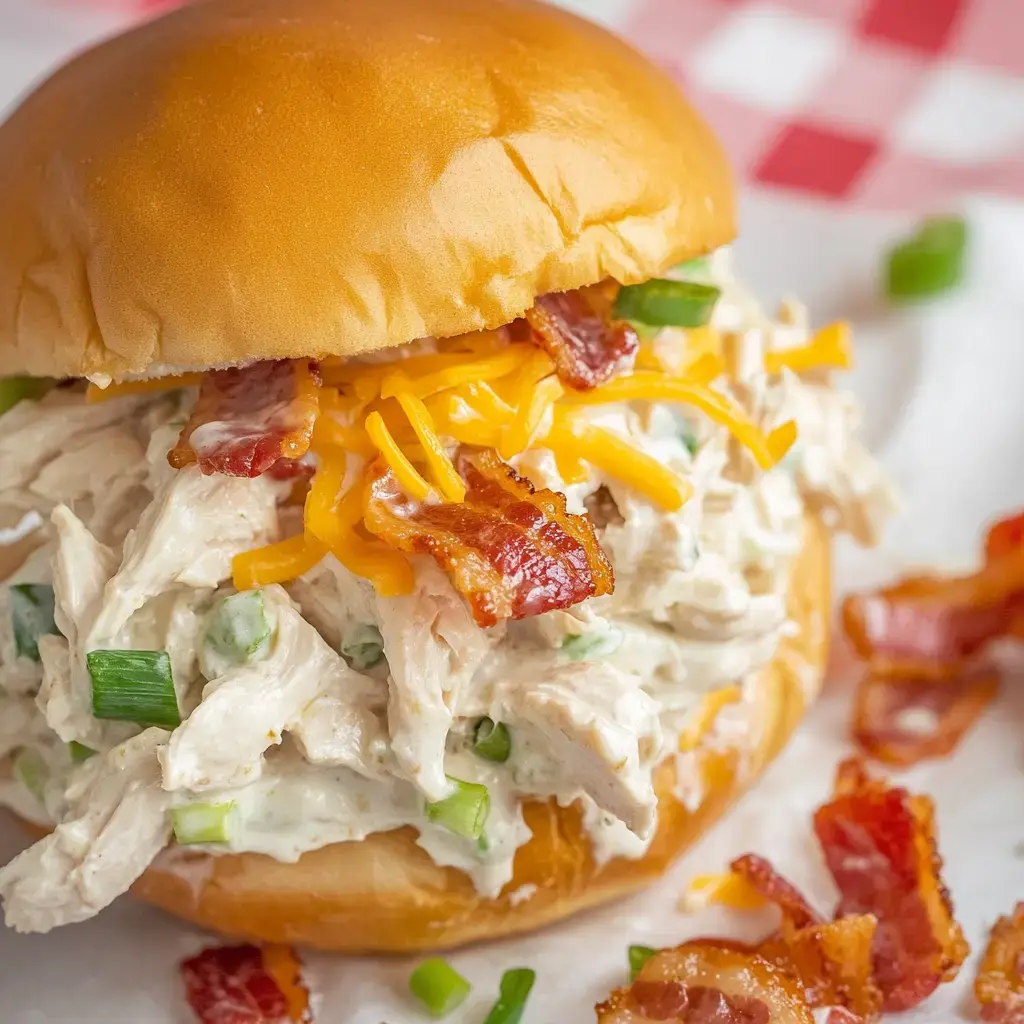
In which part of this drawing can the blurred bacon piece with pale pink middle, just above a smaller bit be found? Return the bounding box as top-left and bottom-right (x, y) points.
(843, 549), (1024, 679)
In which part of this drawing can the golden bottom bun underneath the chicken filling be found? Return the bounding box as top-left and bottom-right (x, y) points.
(121, 518), (829, 952)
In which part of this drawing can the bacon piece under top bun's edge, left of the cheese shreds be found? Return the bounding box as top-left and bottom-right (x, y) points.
(167, 359), (319, 477)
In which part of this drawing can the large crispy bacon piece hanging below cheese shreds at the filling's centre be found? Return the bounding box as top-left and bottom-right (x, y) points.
(365, 450), (614, 627)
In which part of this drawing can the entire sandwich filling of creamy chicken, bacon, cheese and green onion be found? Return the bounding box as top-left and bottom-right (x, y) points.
(0, 252), (892, 931)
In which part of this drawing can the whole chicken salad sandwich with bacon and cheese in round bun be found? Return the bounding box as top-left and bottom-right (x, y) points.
(0, 0), (890, 951)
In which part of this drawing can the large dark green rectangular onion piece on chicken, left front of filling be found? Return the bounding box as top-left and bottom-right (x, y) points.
(85, 650), (181, 729)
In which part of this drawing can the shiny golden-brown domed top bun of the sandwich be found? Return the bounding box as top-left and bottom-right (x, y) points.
(0, 0), (734, 378)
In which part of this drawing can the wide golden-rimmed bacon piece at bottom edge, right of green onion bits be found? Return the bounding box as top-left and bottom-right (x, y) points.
(597, 939), (814, 1024)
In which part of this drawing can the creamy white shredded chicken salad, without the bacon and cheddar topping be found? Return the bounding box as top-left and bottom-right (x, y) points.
(0, 252), (892, 931)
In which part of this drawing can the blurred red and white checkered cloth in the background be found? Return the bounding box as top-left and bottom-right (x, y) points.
(18, 0), (1024, 212)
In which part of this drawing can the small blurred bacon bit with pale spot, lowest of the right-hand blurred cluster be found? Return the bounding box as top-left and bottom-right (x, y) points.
(853, 667), (999, 768)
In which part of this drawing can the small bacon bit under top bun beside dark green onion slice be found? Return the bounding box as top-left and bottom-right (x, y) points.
(526, 290), (640, 391)
